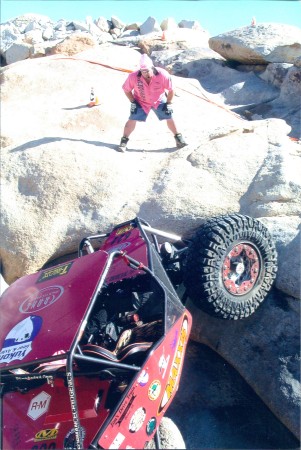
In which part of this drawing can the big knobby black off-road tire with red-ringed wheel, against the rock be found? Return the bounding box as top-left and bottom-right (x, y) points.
(183, 214), (277, 319)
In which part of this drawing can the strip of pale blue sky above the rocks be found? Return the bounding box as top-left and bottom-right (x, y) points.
(0, 0), (301, 36)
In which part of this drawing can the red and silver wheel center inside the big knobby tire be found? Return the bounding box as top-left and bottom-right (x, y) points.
(222, 243), (260, 295)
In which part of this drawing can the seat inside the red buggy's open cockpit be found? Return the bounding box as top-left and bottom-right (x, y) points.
(81, 320), (163, 362)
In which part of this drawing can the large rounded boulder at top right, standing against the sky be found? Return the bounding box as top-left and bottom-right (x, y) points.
(209, 23), (301, 64)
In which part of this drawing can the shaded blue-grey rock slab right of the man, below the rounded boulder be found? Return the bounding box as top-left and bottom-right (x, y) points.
(146, 44), (301, 138)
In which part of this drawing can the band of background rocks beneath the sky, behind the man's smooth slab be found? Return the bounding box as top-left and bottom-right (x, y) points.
(1, 14), (301, 138)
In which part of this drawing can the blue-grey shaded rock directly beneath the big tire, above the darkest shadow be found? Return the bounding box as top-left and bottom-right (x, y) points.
(187, 291), (301, 439)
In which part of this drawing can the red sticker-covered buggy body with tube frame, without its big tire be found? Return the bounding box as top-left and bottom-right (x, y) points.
(0, 217), (192, 450)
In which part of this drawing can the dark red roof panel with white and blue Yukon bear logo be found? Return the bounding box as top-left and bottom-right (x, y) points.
(0, 252), (108, 367)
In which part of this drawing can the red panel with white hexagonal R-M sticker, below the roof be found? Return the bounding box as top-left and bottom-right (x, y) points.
(3, 377), (109, 450)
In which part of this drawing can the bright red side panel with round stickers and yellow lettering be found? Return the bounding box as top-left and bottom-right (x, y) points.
(99, 311), (192, 449)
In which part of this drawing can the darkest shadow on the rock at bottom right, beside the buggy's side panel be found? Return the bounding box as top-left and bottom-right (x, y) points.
(167, 341), (299, 450)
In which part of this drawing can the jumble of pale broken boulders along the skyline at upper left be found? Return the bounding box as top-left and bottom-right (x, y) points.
(0, 14), (209, 64)
